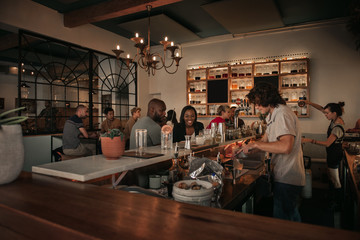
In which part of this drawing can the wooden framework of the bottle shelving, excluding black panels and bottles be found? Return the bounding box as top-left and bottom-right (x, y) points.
(186, 58), (310, 118)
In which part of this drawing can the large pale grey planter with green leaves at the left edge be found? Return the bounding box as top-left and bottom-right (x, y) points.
(0, 107), (28, 184)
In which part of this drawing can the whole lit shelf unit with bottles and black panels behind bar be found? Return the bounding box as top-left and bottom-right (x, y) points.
(186, 58), (310, 118)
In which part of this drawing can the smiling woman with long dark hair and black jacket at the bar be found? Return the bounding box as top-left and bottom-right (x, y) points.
(173, 105), (204, 142)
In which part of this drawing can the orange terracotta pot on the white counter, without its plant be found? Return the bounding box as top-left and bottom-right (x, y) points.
(101, 137), (125, 160)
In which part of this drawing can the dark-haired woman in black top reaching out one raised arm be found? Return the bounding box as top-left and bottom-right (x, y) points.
(302, 101), (345, 207)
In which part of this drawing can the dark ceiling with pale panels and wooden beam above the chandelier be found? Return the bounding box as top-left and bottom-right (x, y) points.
(28, 0), (351, 44)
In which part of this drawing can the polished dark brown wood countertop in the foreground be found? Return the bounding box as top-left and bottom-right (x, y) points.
(0, 173), (360, 240)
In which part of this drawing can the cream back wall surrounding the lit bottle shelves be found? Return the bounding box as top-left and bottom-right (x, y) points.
(145, 23), (360, 133)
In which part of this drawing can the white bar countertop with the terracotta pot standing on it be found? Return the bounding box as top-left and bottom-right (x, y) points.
(32, 146), (191, 182)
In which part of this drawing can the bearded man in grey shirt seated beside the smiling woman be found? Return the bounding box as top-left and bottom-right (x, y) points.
(130, 98), (166, 149)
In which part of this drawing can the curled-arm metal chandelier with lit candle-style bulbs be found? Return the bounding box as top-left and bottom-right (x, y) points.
(112, 5), (182, 76)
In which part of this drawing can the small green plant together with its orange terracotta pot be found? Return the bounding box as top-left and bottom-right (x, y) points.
(100, 129), (125, 160)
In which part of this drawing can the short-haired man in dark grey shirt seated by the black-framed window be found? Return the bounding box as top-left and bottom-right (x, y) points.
(63, 105), (97, 156)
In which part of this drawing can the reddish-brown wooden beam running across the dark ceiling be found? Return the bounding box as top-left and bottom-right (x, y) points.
(64, 0), (182, 28)
